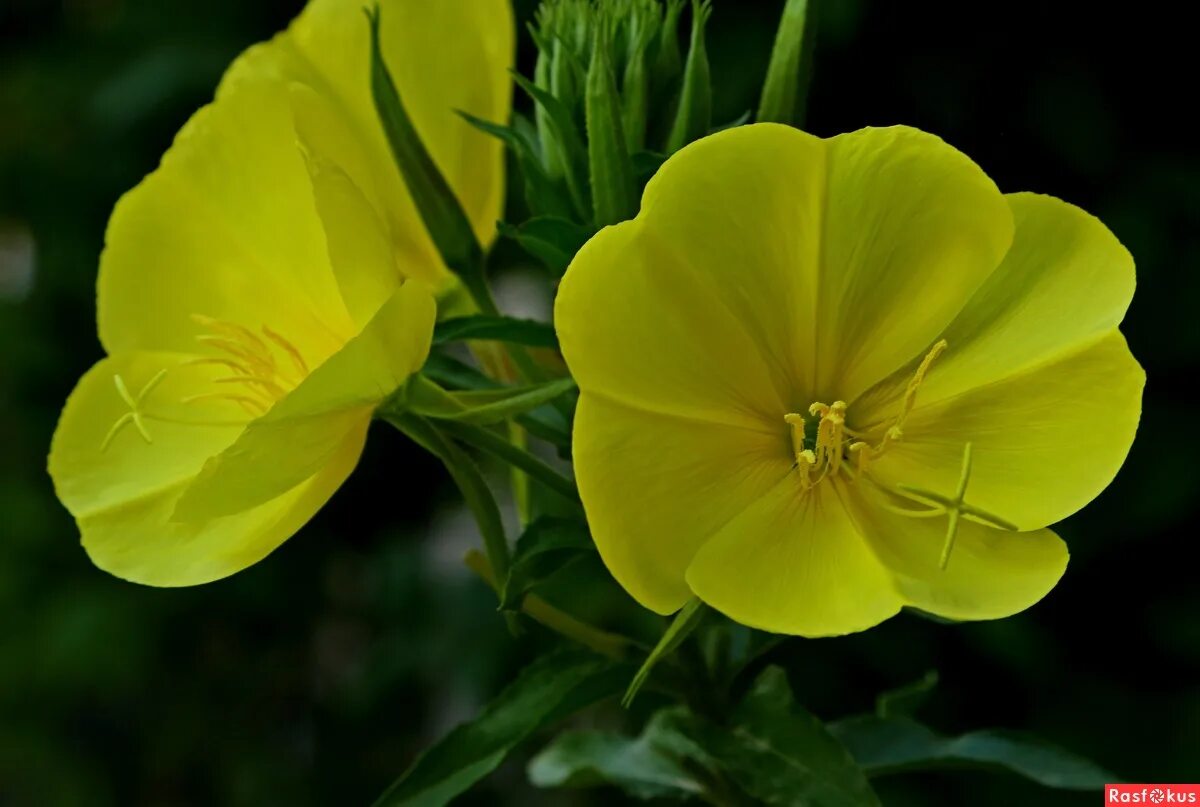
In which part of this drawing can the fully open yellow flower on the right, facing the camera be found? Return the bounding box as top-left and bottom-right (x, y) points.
(556, 124), (1145, 636)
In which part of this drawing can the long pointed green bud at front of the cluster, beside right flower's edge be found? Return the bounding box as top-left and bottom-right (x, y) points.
(583, 17), (637, 227)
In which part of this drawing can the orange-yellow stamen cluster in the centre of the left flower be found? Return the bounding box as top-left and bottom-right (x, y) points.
(184, 313), (308, 417)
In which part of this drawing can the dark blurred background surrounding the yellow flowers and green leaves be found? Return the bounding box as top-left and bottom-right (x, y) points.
(0, 0), (1200, 806)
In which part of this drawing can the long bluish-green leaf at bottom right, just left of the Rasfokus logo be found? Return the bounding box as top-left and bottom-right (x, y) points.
(829, 716), (1121, 790)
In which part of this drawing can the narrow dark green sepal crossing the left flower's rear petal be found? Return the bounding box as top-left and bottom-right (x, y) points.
(366, 6), (477, 283)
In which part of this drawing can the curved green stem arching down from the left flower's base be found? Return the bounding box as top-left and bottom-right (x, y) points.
(379, 410), (509, 588)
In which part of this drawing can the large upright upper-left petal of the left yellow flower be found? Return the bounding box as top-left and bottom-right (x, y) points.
(98, 82), (353, 364)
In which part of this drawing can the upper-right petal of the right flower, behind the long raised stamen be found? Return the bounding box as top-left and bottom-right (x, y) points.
(853, 193), (1134, 413)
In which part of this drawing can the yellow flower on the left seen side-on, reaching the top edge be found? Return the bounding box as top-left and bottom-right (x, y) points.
(49, 0), (514, 586)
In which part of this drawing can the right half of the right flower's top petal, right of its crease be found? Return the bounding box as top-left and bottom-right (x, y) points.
(816, 126), (1013, 401)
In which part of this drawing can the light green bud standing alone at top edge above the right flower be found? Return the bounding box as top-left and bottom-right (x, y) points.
(758, 0), (817, 127)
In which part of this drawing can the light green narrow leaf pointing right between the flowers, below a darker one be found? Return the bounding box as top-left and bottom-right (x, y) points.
(403, 373), (575, 426)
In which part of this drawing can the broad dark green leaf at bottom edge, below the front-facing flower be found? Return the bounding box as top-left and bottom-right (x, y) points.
(688, 666), (880, 807)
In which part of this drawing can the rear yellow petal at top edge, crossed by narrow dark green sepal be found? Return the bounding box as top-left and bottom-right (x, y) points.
(282, 0), (515, 281)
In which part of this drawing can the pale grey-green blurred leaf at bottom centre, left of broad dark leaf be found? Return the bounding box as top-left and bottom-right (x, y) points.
(528, 711), (707, 800)
